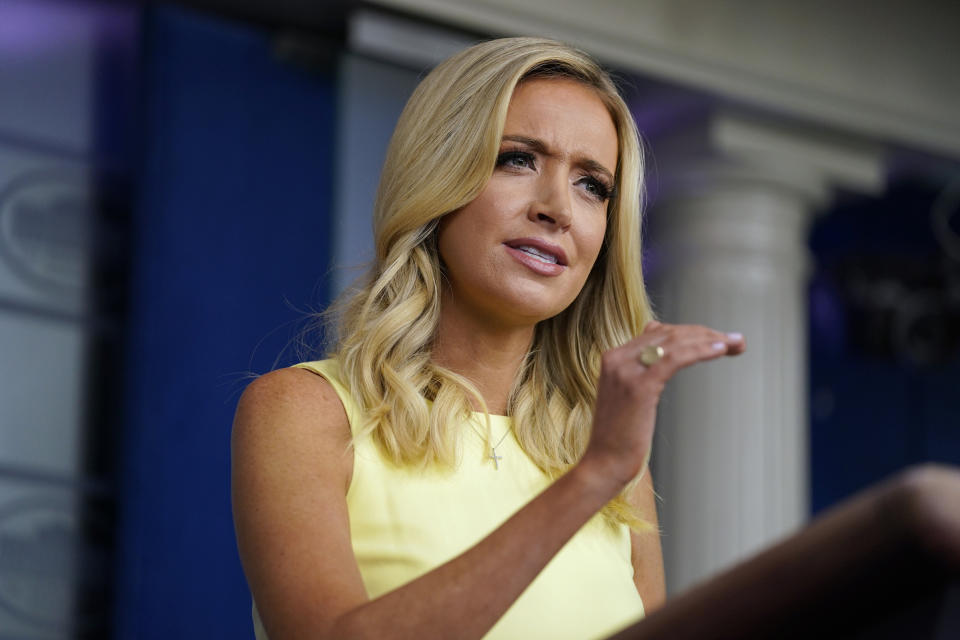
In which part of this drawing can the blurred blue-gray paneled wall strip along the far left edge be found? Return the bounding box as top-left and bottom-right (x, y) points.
(0, 6), (108, 640)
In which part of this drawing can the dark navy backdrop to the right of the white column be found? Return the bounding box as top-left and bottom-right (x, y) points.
(810, 178), (960, 514)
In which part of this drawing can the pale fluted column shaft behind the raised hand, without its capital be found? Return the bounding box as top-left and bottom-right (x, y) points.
(652, 181), (809, 592)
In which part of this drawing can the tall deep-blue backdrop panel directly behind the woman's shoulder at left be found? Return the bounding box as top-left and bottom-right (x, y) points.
(115, 8), (335, 640)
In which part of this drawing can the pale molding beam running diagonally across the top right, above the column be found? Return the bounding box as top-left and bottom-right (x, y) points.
(364, 0), (960, 157)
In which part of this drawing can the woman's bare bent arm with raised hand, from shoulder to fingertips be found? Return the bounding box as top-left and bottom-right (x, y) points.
(233, 325), (737, 640)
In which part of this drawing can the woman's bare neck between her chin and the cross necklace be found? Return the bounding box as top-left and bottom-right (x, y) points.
(432, 288), (534, 415)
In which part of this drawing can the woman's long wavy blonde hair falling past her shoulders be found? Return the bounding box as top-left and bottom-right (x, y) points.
(332, 38), (652, 528)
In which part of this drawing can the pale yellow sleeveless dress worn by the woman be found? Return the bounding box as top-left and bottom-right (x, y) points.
(253, 360), (644, 640)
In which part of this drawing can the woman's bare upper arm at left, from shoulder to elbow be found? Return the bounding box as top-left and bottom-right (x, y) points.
(231, 369), (367, 637)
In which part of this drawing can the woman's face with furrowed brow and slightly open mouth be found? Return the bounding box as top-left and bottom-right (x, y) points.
(439, 78), (618, 325)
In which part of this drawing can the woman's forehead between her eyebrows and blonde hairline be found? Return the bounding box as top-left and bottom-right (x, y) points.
(504, 78), (618, 172)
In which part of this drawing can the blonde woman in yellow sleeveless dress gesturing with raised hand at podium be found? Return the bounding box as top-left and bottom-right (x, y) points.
(233, 38), (744, 640)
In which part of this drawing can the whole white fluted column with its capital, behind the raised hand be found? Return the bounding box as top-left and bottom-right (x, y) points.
(647, 115), (881, 593)
